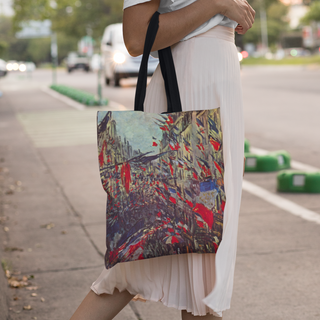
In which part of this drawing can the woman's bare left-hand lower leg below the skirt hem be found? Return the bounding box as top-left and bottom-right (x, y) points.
(70, 289), (134, 320)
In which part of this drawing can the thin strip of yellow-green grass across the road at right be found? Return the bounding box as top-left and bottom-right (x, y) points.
(241, 55), (320, 65)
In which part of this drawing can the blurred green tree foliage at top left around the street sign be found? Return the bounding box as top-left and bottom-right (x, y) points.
(10, 0), (122, 63)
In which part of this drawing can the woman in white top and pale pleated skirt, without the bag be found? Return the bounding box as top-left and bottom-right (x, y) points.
(71, 0), (255, 320)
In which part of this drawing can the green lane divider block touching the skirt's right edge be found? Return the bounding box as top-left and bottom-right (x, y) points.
(245, 150), (291, 172)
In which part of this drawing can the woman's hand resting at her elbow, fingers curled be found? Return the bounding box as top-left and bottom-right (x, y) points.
(219, 0), (256, 34)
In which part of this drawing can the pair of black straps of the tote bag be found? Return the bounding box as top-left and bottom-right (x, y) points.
(134, 12), (182, 113)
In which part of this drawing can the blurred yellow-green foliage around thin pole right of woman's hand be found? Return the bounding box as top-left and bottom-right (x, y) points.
(243, 0), (289, 46)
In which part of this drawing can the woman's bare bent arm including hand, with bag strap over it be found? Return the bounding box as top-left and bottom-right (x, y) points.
(123, 0), (255, 56)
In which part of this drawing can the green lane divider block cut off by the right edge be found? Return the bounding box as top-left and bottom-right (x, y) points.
(277, 170), (320, 193)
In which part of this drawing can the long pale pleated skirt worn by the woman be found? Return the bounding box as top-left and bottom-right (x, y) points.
(91, 25), (244, 316)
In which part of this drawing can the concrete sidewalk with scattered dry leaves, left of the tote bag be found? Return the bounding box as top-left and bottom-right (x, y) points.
(0, 88), (179, 320)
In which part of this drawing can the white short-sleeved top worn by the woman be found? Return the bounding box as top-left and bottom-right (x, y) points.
(123, 0), (238, 41)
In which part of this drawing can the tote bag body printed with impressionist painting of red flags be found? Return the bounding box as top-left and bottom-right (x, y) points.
(98, 108), (226, 268)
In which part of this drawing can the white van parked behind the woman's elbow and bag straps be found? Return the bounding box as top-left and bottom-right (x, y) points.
(101, 23), (159, 86)
